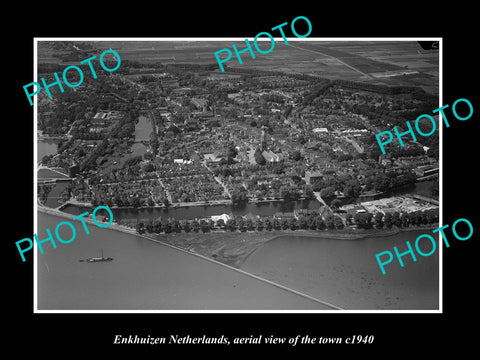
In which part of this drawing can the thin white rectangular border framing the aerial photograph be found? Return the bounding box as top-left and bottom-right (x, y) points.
(33, 37), (443, 314)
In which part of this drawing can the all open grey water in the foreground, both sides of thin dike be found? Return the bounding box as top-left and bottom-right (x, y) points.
(38, 212), (438, 310)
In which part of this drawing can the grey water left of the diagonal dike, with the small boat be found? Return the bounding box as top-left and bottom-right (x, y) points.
(35, 212), (329, 310)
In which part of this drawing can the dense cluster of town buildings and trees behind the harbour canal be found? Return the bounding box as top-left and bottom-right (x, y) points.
(39, 45), (438, 231)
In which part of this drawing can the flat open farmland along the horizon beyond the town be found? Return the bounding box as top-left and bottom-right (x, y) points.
(38, 39), (439, 93)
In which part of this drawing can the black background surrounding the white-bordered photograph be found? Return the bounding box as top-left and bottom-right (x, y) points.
(2, 2), (480, 358)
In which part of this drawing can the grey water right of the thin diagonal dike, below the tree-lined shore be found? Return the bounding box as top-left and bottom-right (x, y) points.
(242, 230), (439, 310)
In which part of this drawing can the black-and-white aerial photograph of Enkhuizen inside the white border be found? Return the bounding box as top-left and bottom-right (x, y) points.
(35, 38), (441, 312)
